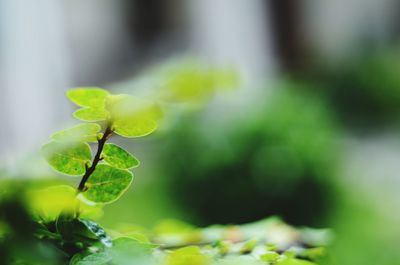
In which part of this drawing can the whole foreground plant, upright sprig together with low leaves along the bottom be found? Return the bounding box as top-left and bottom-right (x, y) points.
(0, 77), (328, 265)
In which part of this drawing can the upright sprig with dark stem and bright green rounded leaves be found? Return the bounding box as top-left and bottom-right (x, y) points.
(42, 88), (161, 204)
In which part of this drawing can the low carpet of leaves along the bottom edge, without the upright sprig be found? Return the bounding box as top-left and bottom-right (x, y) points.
(0, 193), (331, 265)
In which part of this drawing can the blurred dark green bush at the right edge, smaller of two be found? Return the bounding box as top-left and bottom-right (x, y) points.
(312, 48), (400, 129)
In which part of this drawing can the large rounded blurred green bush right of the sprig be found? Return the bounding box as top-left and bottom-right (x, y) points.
(157, 82), (339, 225)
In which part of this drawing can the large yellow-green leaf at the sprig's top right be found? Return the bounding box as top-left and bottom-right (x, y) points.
(107, 95), (162, 138)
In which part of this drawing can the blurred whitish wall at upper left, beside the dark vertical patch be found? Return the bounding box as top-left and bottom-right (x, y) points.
(0, 0), (126, 173)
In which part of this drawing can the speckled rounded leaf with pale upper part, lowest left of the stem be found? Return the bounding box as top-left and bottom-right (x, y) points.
(41, 141), (92, 176)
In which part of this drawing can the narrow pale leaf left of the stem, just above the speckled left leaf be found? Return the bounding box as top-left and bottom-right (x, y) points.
(51, 123), (101, 142)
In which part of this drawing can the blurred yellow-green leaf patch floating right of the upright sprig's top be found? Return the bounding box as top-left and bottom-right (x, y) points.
(111, 58), (241, 109)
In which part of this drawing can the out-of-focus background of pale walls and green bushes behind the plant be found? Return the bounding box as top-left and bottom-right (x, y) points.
(0, 0), (400, 264)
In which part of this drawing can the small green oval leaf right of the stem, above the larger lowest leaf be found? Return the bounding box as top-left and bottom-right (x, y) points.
(101, 144), (139, 169)
